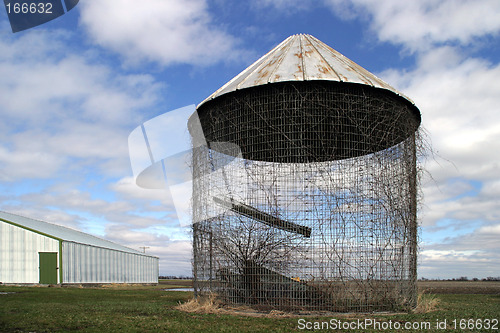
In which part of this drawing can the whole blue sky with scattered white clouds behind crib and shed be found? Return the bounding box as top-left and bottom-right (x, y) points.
(0, 0), (500, 278)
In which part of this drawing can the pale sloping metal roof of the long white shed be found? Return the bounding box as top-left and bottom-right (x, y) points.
(0, 211), (152, 255)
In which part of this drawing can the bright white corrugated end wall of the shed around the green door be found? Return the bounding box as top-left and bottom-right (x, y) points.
(0, 221), (59, 283)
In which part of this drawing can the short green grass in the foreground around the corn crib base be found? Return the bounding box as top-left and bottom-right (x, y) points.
(0, 285), (500, 333)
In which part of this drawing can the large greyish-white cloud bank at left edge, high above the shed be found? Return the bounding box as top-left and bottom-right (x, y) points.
(0, 30), (162, 181)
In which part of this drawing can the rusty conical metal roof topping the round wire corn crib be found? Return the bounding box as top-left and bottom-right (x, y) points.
(200, 34), (414, 105)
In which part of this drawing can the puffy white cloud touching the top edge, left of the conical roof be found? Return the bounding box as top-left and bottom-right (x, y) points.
(79, 0), (245, 65)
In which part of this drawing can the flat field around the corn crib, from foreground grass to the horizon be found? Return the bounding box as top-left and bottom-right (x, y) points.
(0, 280), (500, 333)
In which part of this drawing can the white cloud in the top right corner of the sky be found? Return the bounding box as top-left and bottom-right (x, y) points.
(324, 0), (500, 51)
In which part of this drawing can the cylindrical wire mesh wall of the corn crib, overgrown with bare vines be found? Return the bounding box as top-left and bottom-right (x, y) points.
(189, 81), (420, 311)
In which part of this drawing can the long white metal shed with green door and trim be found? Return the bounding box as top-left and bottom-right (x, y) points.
(0, 212), (158, 284)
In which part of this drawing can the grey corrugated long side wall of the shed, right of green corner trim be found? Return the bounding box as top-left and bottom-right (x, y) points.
(63, 242), (158, 283)
